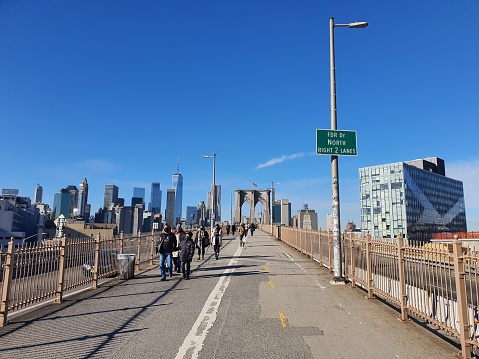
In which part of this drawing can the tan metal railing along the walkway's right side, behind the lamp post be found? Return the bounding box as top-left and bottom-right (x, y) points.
(259, 225), (479, 358)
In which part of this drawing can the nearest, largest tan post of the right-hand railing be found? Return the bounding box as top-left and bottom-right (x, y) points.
(452, 235), (471, 358)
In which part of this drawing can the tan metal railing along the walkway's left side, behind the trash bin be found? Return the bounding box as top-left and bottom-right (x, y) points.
(0, 232), (160, 326)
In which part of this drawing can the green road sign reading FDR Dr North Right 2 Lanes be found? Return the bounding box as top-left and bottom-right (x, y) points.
(316, 129), (358, 156)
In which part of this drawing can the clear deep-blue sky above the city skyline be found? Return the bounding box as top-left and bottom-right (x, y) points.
(0, 0), (479, 231)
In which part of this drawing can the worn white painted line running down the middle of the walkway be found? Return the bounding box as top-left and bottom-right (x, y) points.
(176, 243), (243, 359)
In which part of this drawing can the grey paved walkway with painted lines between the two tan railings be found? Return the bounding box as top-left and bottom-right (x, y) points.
(0, 230), (460, 359)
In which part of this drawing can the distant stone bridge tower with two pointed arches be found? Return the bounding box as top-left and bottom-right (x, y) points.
(234, 189), (271, 224)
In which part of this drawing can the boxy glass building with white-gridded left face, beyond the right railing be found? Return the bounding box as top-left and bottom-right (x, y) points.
(359, 157), (467, 243)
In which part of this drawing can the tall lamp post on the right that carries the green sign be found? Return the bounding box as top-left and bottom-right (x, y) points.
(329, 17), (368, 283)
